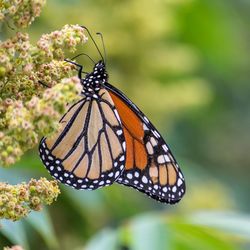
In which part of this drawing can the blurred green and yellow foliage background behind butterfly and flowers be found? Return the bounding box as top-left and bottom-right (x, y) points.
(0, 0), (250, 250)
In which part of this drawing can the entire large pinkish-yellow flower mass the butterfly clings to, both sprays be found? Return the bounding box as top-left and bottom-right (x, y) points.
(0, 25), (87, 166)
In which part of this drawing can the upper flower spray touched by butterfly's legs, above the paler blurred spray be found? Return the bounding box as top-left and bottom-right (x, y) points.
(0, 25), (87, 100)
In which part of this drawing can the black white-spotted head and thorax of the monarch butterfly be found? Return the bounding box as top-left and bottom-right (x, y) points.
(81, 61), (108, 96)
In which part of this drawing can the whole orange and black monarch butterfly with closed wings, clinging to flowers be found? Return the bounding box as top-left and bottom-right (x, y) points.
(39, 27), (185, 204)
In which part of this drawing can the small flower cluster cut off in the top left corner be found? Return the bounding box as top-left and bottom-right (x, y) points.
(0, 0), (46, 28)
